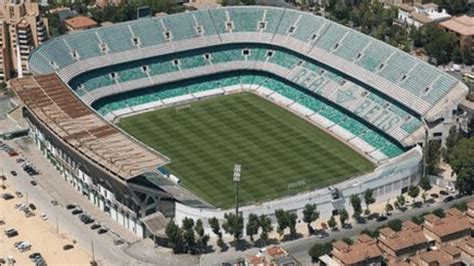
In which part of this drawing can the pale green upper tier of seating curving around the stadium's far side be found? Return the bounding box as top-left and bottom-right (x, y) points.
(30, 7), (458, 118)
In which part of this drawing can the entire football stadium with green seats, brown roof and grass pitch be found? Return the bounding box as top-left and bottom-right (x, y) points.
(11, 7), (468, 237)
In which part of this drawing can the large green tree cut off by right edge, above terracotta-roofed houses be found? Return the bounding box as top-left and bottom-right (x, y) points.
(449, 138), (474, 195)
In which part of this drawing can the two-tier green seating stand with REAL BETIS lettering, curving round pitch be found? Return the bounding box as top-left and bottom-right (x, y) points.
(30, 7), (465, 160)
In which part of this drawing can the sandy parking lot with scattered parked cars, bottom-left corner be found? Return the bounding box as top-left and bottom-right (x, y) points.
(0, 185), (91, 265)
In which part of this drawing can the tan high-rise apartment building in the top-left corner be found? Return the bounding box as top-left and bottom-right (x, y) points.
(0, 0), (48, 80)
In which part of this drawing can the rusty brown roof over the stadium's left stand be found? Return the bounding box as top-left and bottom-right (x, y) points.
(11, 74), (169, 181)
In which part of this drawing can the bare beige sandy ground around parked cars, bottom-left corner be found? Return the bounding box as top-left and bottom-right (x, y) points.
(0, 186), (91, 265)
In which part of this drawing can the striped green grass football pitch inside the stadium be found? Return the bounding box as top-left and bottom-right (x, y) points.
(118, 93), (374, 208)
